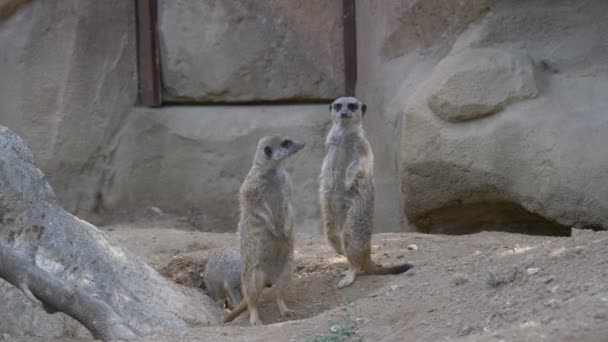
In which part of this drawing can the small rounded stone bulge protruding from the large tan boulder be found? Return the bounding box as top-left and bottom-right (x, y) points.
(428, 48), (538, 122)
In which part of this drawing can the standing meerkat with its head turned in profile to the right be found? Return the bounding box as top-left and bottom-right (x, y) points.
(224, 136), (304, 325)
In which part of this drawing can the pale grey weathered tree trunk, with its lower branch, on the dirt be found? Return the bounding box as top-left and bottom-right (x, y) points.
(0, 126), (222, 340)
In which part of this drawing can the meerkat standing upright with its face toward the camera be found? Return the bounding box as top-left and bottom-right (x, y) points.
(319, 97), (413, 288)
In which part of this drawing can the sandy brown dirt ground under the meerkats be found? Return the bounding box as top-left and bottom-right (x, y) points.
(9, 214), (608, 342)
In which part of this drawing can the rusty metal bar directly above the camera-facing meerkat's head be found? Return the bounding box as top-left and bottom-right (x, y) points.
(342, 0), (357, 96)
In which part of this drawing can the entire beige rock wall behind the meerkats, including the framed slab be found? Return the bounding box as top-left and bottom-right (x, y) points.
(0, 0), (608, 236)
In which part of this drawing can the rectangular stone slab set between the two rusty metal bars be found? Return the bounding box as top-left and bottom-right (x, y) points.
(159, 0), (344, 103)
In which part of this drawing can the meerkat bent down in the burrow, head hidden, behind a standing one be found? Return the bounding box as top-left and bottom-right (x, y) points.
(203, 247), (241, 309)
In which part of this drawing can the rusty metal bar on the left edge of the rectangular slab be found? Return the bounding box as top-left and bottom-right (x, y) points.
(135, 0), (162, 107)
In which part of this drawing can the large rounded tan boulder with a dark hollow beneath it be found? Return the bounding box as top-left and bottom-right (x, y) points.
(400, 0), (608, 234)
